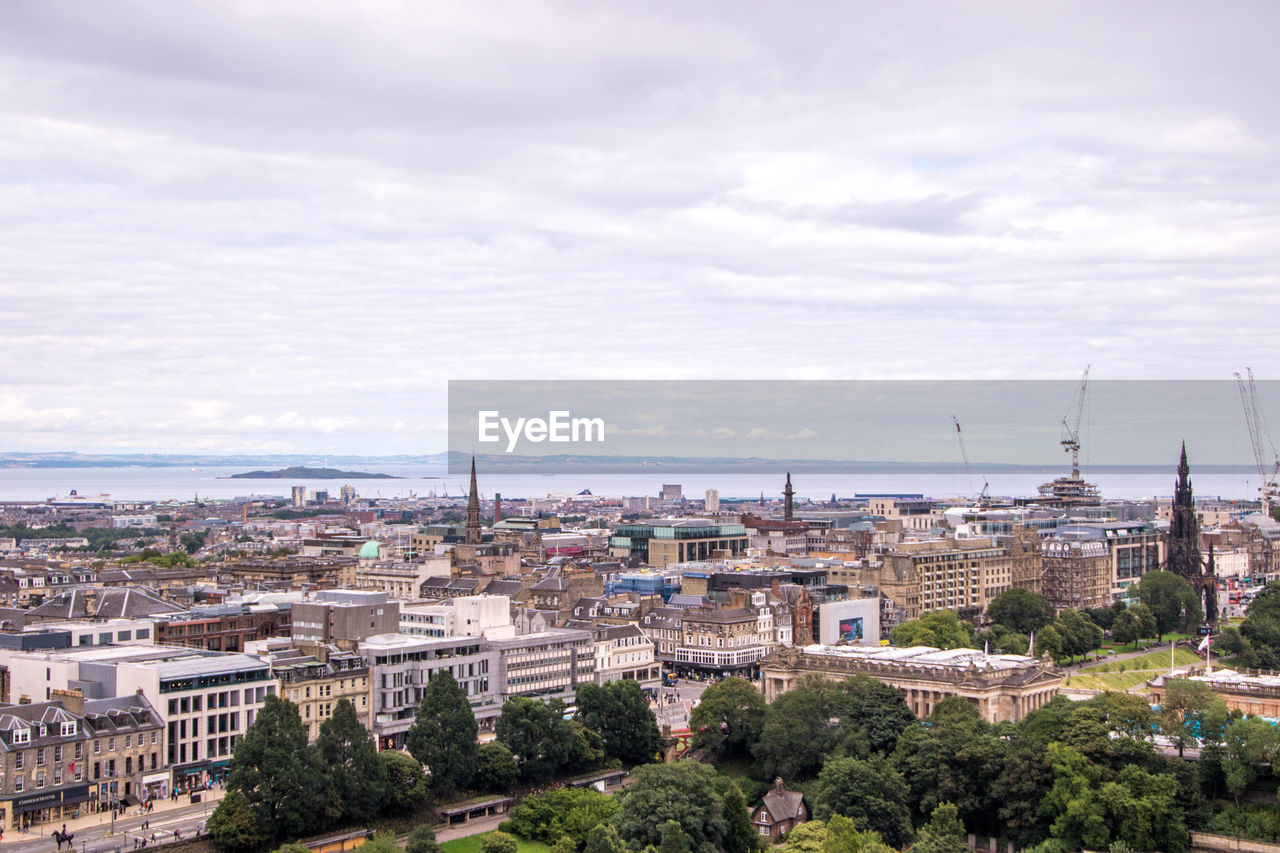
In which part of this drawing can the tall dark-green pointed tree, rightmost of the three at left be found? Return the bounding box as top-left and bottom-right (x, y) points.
(404, 669), (480, 794)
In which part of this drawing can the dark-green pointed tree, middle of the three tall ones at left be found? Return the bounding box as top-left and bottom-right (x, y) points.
(316, 698), (388, 824)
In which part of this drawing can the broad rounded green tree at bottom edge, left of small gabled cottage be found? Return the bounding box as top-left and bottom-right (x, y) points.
(613, 761), (726, 853)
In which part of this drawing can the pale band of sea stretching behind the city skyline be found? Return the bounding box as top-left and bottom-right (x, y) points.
(0, 464), (1258, 501)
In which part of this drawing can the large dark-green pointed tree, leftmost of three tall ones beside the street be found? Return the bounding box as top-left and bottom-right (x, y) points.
(227, 693), (329, 841)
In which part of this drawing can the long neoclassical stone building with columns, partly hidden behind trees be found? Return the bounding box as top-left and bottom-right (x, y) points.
(760, 646), (1062, 722)
